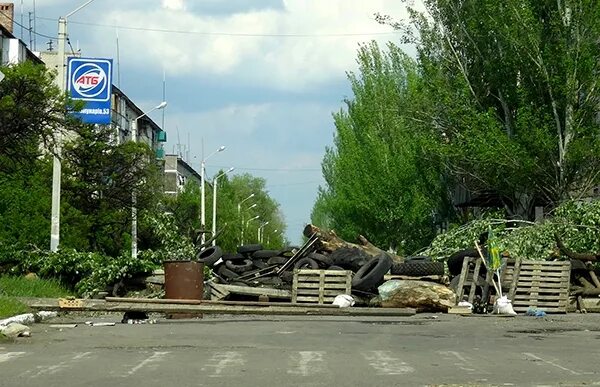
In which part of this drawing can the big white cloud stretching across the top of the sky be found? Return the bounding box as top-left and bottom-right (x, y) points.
(91, 0), (414, 91)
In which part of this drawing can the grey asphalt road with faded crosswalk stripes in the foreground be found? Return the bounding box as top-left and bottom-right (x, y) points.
(0, 314), (600, 387)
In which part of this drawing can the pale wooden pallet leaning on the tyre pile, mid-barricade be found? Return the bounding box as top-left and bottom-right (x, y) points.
(292, 269), (352, 304)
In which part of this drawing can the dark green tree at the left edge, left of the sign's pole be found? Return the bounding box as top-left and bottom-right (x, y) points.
(0, 62), (80, 248)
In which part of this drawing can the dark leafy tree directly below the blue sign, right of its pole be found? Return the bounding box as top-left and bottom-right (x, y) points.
(62, 125), (162, 256)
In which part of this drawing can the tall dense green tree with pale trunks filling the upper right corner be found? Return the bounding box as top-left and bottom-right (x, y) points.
(380, 0), (600, 218)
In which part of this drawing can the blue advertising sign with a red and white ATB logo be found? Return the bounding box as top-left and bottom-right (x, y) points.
(67, 57), (112, 124)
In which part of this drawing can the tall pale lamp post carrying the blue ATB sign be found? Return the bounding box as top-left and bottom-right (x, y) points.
(50, 0), (94, 251)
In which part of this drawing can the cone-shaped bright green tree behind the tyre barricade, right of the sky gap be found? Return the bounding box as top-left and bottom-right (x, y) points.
(313, 43), (446, 252)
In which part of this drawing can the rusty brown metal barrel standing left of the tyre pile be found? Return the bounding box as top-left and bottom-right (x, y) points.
(163, 261), (204, 300)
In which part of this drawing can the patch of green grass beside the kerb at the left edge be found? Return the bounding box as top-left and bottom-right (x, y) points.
(0, 276), (72, 319)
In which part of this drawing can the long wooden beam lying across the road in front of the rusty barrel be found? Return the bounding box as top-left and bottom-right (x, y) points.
(20, 298), (416, 316)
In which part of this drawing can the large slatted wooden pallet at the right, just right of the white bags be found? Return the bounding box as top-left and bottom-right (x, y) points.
(508, 260), (571, 313)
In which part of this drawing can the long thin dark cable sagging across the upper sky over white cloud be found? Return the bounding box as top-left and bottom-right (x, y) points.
(38, 17), (398, 38)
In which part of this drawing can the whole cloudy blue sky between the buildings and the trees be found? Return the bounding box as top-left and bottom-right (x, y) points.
(22, 0), (418, 243)
